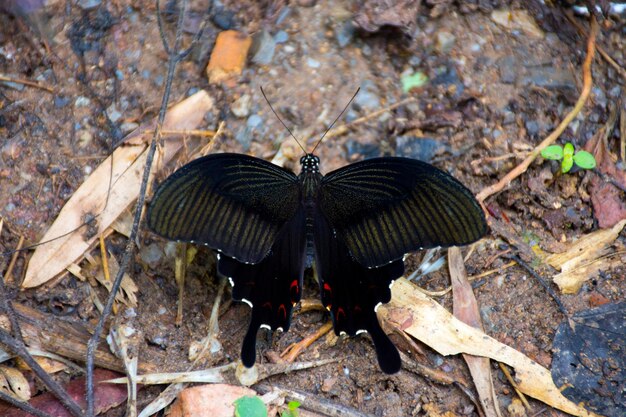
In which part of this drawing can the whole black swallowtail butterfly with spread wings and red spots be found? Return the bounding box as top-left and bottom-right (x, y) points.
(148, 153), (487, 373)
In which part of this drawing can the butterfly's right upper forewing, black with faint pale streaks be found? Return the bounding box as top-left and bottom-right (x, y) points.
(318, 158), (487, 268)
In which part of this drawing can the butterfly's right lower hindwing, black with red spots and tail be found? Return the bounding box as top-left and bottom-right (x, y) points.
(314, 209), (404, 374)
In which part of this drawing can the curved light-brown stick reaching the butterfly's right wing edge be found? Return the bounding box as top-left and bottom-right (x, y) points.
(476, 16), (598, 203)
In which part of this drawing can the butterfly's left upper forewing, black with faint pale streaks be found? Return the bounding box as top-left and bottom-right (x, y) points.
(148, 153), (300, 264)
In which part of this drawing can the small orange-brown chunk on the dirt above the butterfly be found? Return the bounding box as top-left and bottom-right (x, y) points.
(206, 30), (252, 84)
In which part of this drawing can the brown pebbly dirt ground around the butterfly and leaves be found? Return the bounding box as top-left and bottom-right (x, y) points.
(0, 0), (626, 416)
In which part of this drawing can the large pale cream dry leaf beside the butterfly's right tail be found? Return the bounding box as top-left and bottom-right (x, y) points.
(378, 278), (597, 416)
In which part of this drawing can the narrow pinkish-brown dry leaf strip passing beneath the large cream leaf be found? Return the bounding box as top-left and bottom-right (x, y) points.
(448, 247), (502, 417)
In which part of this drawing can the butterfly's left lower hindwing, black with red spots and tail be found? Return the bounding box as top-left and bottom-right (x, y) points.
(217, 208), (306, 367)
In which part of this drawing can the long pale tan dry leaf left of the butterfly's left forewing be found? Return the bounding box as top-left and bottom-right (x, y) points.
(22, 90), (213, 288)
